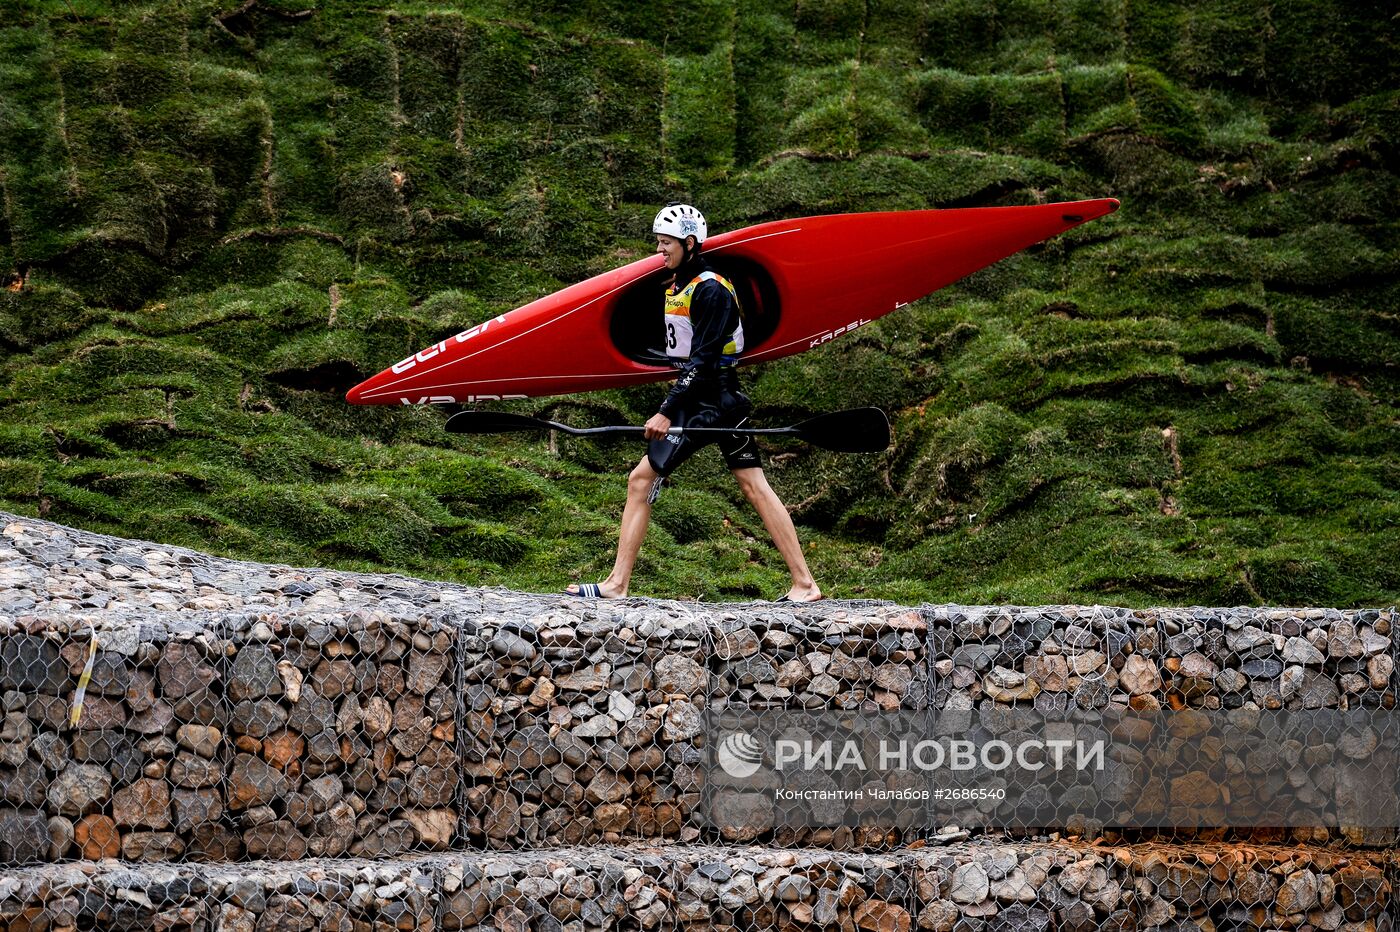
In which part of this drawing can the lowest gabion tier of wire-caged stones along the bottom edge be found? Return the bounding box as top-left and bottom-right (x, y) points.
(0, 841), (1396, 932)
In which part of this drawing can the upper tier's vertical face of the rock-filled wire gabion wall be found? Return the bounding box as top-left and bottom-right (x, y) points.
(0, 603), (1394, 863)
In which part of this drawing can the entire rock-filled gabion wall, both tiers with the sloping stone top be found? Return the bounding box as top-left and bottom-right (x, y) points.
(0, 518), (1400, 932)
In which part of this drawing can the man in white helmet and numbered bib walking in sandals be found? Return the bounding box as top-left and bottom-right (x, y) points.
(567, 204), (822, 602)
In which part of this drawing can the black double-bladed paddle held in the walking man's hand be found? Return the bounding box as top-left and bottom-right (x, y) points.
(447, 407), (889, 453)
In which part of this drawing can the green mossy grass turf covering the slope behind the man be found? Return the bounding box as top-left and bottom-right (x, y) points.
(0, 0), (1400, 606)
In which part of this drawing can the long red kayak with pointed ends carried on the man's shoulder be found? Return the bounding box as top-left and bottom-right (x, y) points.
(346, 197), (1119, 404)
